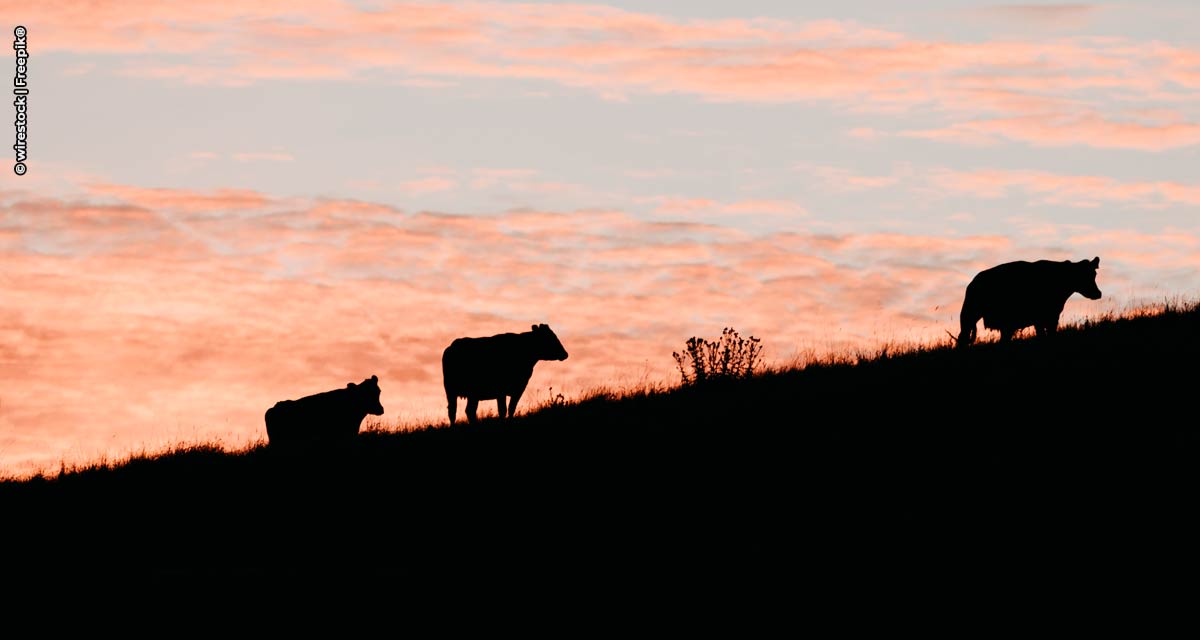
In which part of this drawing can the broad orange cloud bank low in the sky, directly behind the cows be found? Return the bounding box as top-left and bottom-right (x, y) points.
(0, 185), (1200, 473)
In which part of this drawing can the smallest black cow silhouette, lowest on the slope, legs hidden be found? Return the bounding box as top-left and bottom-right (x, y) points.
(265, 376), (383, 447)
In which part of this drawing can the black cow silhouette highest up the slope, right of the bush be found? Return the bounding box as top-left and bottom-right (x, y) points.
(958, 257), (1100, 348)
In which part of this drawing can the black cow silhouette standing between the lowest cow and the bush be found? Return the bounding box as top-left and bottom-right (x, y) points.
(442, 324), (566, 425)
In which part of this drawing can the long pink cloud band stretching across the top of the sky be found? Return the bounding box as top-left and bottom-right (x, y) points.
(24, 0), (1200, 150)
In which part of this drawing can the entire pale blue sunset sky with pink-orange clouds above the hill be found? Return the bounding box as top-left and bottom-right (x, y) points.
(0, 0), (1200, 474)
